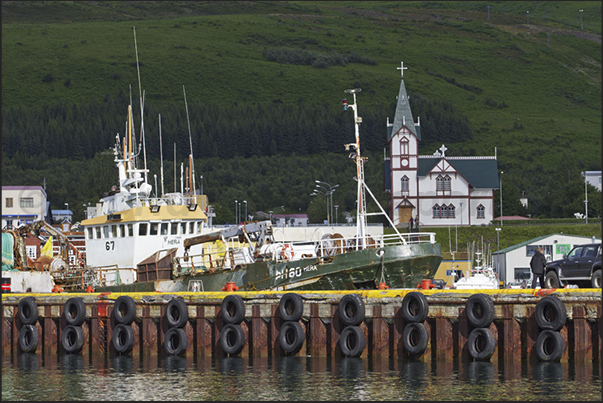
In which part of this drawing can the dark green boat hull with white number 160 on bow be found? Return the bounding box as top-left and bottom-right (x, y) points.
(96, 243), (442, 292)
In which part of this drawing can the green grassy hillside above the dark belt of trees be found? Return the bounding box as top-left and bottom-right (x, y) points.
(2, 1), (601, 221)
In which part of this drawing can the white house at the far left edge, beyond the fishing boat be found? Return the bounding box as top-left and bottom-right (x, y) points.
(2, 186), (48, 228)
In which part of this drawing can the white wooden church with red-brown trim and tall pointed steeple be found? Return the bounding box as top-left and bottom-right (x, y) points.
(385, 63), (499, 227)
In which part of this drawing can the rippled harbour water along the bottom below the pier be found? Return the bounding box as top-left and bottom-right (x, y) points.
(2, 354), (602, 401)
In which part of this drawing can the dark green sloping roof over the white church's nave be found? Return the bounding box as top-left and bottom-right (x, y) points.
(417, 157), (499, 189)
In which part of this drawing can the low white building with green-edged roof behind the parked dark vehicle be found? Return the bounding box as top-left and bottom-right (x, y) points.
(492, 234), (601, 285)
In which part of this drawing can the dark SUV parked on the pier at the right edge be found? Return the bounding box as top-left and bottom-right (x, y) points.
(544, 243), (601, 288)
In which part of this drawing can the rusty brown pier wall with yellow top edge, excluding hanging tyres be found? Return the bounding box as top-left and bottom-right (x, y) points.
(2, 289), (602, 365)
